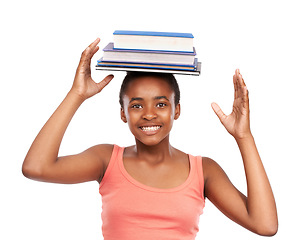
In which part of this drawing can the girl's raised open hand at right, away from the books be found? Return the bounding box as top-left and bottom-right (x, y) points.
(212, 69), (251, 139)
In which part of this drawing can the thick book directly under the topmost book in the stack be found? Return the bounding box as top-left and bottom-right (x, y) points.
(102, 42), (196, 65)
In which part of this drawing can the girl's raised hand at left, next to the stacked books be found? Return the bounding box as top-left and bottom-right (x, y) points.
(71, 38), (114, 101)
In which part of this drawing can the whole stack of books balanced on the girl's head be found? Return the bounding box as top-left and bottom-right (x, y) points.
(96, 30), (201, 75)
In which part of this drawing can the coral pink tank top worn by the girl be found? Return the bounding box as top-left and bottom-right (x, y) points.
(99, 145), (205, 240)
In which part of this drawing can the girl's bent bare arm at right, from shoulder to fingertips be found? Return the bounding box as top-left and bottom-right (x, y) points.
(204, 70), (278, 236)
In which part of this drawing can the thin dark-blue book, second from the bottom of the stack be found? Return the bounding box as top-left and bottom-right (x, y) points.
(97, 58), (198, 71)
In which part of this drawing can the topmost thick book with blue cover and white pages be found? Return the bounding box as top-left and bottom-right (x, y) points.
(113, 30), (194, 52)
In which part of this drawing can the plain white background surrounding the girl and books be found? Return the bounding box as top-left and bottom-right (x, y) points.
(0, 0), (302, 240)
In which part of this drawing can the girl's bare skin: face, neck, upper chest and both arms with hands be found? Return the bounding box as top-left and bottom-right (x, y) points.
(22, 39), (278, 236)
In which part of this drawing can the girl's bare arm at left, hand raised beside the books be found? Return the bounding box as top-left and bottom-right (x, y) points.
(22, 39), (113, 183)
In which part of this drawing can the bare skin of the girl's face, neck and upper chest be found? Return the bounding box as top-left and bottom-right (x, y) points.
(121, 77), (189, 188)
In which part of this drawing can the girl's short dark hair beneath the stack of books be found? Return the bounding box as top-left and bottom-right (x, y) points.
(119, 72), (180, 108)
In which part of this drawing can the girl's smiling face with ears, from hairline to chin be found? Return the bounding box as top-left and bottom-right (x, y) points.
(121, 77), (180, 145)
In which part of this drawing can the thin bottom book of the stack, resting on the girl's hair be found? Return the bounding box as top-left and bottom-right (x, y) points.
(96, 62), (201, 76)
